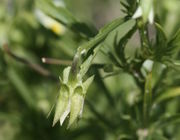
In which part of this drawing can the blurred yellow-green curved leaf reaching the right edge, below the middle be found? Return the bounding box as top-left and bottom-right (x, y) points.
(154, 87), (180, 105)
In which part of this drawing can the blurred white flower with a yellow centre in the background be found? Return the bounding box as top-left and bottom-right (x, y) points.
(35, 9), (65, 35)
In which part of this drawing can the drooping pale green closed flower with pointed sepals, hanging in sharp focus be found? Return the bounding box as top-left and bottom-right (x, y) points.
(53, 67), (94, 127)
